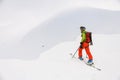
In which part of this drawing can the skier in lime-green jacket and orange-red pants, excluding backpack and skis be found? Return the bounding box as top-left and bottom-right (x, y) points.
(78, 26), (93, 64)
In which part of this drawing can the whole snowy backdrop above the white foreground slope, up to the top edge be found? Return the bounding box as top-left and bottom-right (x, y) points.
(0, 0), (120, 59)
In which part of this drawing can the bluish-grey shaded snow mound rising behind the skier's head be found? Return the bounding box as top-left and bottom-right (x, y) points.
(21, 8), (120, 59)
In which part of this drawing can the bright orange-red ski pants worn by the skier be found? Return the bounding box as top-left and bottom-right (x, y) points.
(78, 42), (93, 60)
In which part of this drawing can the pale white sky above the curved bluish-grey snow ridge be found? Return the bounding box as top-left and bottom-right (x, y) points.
(0, 0), (120, 41)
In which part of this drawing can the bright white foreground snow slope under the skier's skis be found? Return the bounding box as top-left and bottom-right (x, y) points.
(0, 35), (120, 80)
